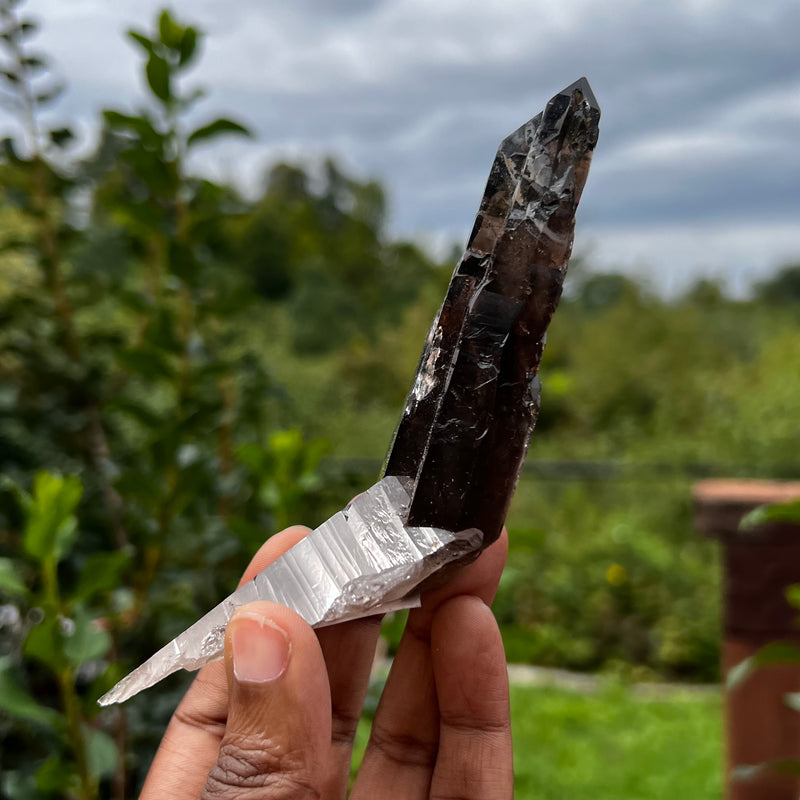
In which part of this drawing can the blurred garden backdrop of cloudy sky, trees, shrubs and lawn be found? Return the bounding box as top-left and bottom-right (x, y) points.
(0, 0), (800, 800)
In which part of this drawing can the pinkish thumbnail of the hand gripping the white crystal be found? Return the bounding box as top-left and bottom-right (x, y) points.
(231, 612), (290, 683)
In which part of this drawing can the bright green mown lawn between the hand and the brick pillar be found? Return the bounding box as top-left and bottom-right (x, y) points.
(357, 686), (722, 800)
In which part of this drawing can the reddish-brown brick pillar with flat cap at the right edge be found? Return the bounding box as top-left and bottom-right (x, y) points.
(694, 480), (800, 800)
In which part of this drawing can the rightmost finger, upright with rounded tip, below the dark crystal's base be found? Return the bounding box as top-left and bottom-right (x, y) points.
(431, 596), (514, 800)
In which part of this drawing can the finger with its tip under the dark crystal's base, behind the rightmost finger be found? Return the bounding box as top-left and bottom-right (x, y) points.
(353, 530), (508, 798)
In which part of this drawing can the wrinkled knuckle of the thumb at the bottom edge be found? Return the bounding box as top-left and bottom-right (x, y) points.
(201, 739), (321, 800)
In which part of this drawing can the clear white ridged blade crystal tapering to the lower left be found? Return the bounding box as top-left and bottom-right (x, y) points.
(98, 476), (482, 706)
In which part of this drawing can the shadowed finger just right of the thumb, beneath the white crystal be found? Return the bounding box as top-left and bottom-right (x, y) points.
(317, 616), (382, 798)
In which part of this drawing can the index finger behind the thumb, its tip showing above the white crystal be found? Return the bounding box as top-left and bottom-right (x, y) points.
(140, 525), (309, 800)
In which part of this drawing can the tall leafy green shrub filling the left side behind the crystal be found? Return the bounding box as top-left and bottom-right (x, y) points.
(0, 3), (368, 800)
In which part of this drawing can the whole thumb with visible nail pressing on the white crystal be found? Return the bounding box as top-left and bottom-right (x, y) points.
(201, 603), (331, 800)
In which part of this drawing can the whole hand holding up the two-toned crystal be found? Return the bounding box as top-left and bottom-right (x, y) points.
(140, 526), (513, 800)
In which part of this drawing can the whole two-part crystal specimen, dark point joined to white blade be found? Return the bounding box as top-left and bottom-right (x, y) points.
(100, 78), (600, 705)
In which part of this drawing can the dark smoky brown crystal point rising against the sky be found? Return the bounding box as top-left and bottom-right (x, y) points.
(384, 78), (600, 547)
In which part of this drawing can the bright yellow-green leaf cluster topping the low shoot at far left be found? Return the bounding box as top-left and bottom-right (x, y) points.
(22, 472), (83, 562)
